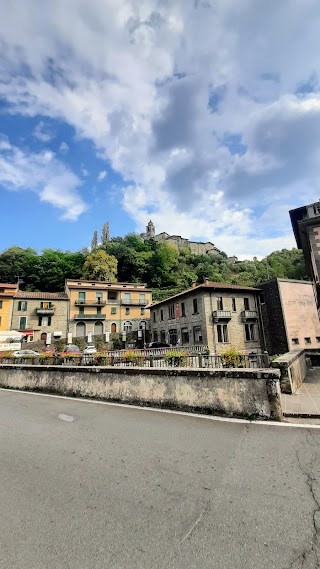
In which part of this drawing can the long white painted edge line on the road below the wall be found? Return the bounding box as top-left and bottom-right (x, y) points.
(0, 387), (320, 429)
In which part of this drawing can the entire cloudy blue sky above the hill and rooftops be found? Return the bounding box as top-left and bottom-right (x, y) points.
(0, 0), (320, 258)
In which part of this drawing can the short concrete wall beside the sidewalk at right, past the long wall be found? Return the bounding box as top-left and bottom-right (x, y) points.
(271, 350), (308, 393)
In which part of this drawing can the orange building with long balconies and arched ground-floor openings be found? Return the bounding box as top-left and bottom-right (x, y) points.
(66, 279), (152, 337)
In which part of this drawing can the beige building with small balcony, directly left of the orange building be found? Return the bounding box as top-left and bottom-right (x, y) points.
(11, 291), (68, 342)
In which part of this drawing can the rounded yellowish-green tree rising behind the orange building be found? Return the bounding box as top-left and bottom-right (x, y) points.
(82, 249), (118, 282)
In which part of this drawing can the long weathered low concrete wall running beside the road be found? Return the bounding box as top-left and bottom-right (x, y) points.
(0, 364), (282, 420)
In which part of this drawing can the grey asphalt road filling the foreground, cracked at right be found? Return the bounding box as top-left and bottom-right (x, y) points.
(0, 390), (320, 569)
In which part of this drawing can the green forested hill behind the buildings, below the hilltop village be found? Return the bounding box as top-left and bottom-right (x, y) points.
(0, 234), (305, 299)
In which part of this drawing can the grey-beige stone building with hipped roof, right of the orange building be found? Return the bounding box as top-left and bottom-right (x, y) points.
(150, 280), (263, 355)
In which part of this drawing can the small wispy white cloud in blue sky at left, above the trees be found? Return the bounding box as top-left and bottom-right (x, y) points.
(0, 135), (87, 221)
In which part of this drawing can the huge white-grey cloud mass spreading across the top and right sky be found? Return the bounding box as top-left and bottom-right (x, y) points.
(0, 0), (320, 255)
